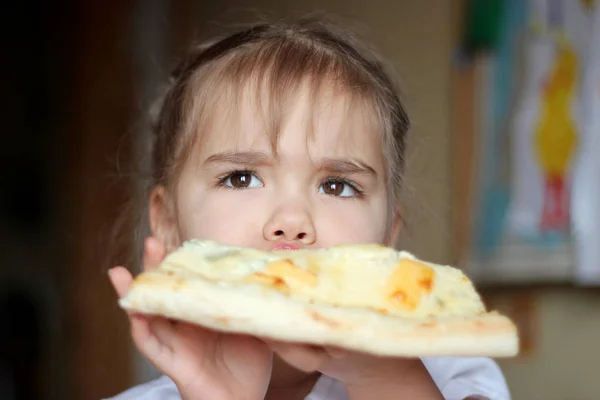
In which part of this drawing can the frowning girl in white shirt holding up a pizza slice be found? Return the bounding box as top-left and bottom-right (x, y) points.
(110, 17), (509, 400)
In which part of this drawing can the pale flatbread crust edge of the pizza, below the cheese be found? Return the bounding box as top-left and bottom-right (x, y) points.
(120, 271), (518, 357)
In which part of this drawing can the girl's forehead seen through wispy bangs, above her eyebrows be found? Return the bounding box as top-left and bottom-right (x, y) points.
(195, 82), (384, 164)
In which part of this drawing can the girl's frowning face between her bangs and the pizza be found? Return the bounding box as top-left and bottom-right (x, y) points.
(151, 85), (395, 250)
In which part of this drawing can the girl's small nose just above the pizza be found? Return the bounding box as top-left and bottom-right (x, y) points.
(263, 207), (316, 245)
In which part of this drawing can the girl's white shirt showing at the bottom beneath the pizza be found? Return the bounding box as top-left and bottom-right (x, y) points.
(105, 357), (510, 400)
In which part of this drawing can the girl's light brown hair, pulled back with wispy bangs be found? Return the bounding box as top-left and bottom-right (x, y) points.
(153, 22), (409, 206)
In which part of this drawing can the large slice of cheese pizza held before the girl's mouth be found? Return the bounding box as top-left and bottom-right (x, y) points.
(120, 240), (518, 357)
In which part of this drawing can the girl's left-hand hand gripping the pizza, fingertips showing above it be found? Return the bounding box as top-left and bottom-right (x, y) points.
(109, 238), (272, 400)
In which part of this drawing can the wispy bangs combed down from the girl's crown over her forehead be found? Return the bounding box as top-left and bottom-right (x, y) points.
(184, 37), (384, 158)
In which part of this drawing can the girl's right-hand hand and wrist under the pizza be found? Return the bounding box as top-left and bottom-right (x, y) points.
(269, 342), (443, 400)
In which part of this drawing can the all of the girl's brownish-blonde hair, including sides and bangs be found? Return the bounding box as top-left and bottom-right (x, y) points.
(150, 19), (409, 203)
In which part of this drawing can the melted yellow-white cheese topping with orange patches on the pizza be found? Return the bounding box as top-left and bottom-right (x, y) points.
(160, 241), (485, 318)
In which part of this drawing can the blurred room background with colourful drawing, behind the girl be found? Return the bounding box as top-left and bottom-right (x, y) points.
(0, 0), (600, 400)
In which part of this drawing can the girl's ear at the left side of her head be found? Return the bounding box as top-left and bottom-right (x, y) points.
(148, 185), (179, 253)
